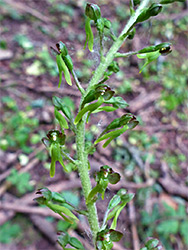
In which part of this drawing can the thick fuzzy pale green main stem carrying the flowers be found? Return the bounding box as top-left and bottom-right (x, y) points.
(76, 0), (150, 245)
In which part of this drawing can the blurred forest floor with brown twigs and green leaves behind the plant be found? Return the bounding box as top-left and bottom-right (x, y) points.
(0, 0), (188, 250)
